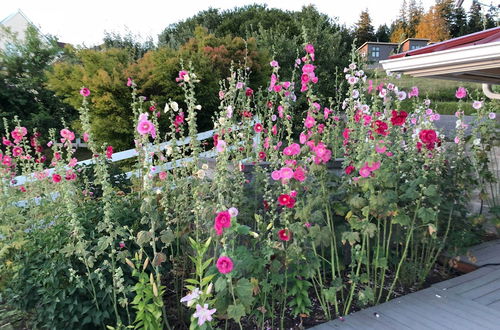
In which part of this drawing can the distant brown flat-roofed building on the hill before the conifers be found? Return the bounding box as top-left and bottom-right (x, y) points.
(356, 38), (429, 68)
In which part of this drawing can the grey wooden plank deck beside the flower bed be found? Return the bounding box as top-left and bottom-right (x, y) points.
(313, 240), (500, 330)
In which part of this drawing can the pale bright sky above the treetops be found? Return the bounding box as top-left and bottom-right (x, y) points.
(0, 0), (472, 46)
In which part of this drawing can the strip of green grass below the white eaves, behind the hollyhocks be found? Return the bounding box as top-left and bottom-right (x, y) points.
(367, 70), (484, 115)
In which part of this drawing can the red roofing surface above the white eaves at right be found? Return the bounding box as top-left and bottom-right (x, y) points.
(389, 27), (500, 59)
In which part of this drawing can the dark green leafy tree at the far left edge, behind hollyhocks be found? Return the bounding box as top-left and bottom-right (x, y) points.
(0, 26), (76, 133)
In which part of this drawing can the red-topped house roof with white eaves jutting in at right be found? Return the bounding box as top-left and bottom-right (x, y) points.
(380, 27), (500, 84)
